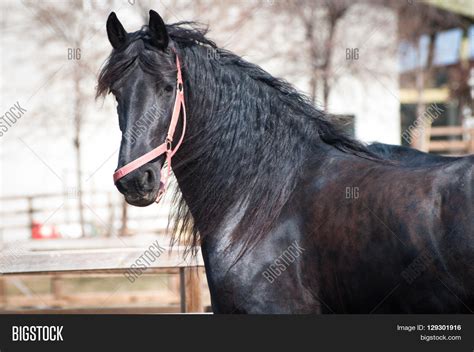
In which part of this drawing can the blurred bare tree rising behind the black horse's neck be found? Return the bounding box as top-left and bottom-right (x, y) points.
(273, 0), (393, 110)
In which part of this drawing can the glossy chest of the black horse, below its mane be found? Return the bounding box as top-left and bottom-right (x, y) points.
(198, 212), (320, 313)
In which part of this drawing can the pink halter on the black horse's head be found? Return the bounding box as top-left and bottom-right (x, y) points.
(114, 49), (186, 203)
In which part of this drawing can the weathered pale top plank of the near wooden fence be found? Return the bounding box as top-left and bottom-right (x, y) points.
(0, 247), (204, 274)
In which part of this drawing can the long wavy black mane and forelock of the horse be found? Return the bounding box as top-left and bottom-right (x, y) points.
(97, 22), (379, 258)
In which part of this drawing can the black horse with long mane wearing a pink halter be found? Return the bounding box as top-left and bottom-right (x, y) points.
(98, 11), (474, 313)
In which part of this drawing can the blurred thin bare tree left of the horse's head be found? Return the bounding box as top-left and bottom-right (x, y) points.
(19, 0), (115, 236)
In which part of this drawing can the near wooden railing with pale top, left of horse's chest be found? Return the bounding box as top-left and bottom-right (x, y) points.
(0, 236), (209, 313)
